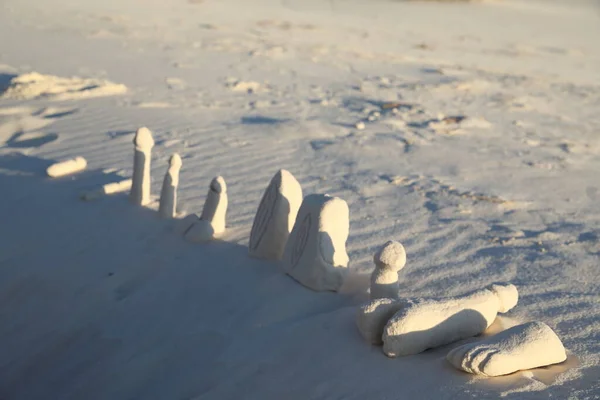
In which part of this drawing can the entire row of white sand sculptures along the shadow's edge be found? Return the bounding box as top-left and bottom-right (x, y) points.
(48, 128), (567, 376)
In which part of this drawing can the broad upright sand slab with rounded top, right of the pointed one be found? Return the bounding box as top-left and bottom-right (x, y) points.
(282, 194), (350, 291)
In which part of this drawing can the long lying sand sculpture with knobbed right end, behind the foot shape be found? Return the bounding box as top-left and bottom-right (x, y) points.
(383, 284), (519, 357)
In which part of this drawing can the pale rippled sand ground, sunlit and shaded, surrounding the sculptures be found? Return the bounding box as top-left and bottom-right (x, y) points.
(0, 0), (600, 400)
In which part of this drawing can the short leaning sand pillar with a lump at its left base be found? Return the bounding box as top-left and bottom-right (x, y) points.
(185, 176), (227, 242)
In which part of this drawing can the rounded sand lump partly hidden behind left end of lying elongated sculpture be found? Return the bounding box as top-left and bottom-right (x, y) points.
(356, 298), (413, 344)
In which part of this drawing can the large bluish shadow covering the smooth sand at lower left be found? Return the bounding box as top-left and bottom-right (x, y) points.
(0, 153), (593, 400)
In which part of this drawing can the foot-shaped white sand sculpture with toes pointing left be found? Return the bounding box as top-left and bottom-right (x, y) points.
(446, 321), (567, 376)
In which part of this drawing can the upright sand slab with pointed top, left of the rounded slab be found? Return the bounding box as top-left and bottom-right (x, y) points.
(248, 169), (302, 260)
